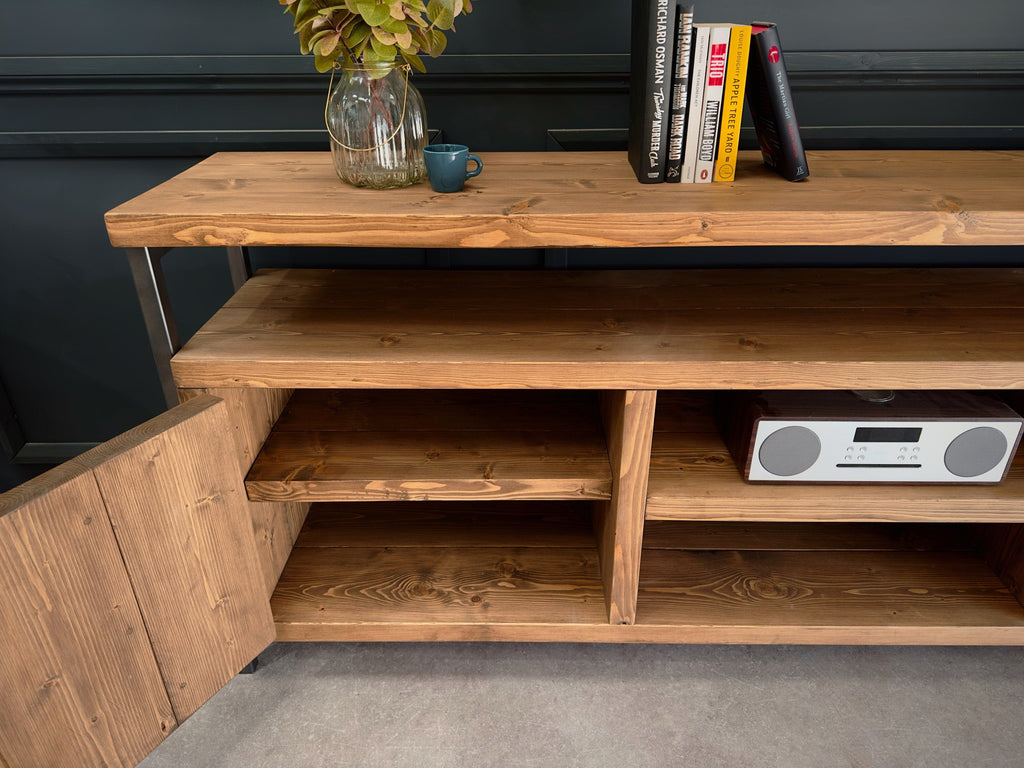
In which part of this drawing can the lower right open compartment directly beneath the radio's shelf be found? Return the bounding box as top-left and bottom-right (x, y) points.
(636, 521), (1024, 644)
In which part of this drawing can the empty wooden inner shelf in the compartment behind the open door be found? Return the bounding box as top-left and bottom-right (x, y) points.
(246, 390), (611, 501)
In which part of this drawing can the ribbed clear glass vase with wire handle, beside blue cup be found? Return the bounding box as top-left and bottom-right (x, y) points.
(325, 62), (427, 189)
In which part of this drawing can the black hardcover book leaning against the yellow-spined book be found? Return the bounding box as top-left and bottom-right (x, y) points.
(746, 22), (809, 181)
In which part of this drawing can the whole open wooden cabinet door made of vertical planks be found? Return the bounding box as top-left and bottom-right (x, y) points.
(0, 396), (274, 768)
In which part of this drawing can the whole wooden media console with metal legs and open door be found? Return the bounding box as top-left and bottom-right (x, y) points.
(0, 152), (1024, 765)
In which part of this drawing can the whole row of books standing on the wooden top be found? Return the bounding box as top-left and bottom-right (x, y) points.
(629, 0), (808, 184)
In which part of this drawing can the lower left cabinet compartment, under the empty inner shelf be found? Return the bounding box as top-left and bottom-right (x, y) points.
(271, 502), (607, 641)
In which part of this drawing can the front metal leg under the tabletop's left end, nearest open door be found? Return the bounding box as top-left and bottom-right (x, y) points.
(125, 248), (181, 408)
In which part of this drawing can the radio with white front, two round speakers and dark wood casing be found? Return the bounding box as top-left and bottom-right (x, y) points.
(719, 391), (1024, 483)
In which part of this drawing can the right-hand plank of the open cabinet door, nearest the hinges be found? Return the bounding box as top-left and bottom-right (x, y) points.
(85, 395), (274, 722)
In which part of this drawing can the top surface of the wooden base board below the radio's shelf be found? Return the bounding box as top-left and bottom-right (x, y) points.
(637, 550), (1024, 643)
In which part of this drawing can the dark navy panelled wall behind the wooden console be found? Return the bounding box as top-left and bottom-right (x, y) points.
(0, 0), (1024, 487)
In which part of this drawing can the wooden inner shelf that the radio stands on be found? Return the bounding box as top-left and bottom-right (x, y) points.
(646, 392), (1024, 522)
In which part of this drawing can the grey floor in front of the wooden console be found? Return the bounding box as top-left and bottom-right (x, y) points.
(141, 643), (1024, 768)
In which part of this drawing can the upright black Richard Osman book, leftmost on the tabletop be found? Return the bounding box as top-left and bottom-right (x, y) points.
(629, 0), (676, 184)
